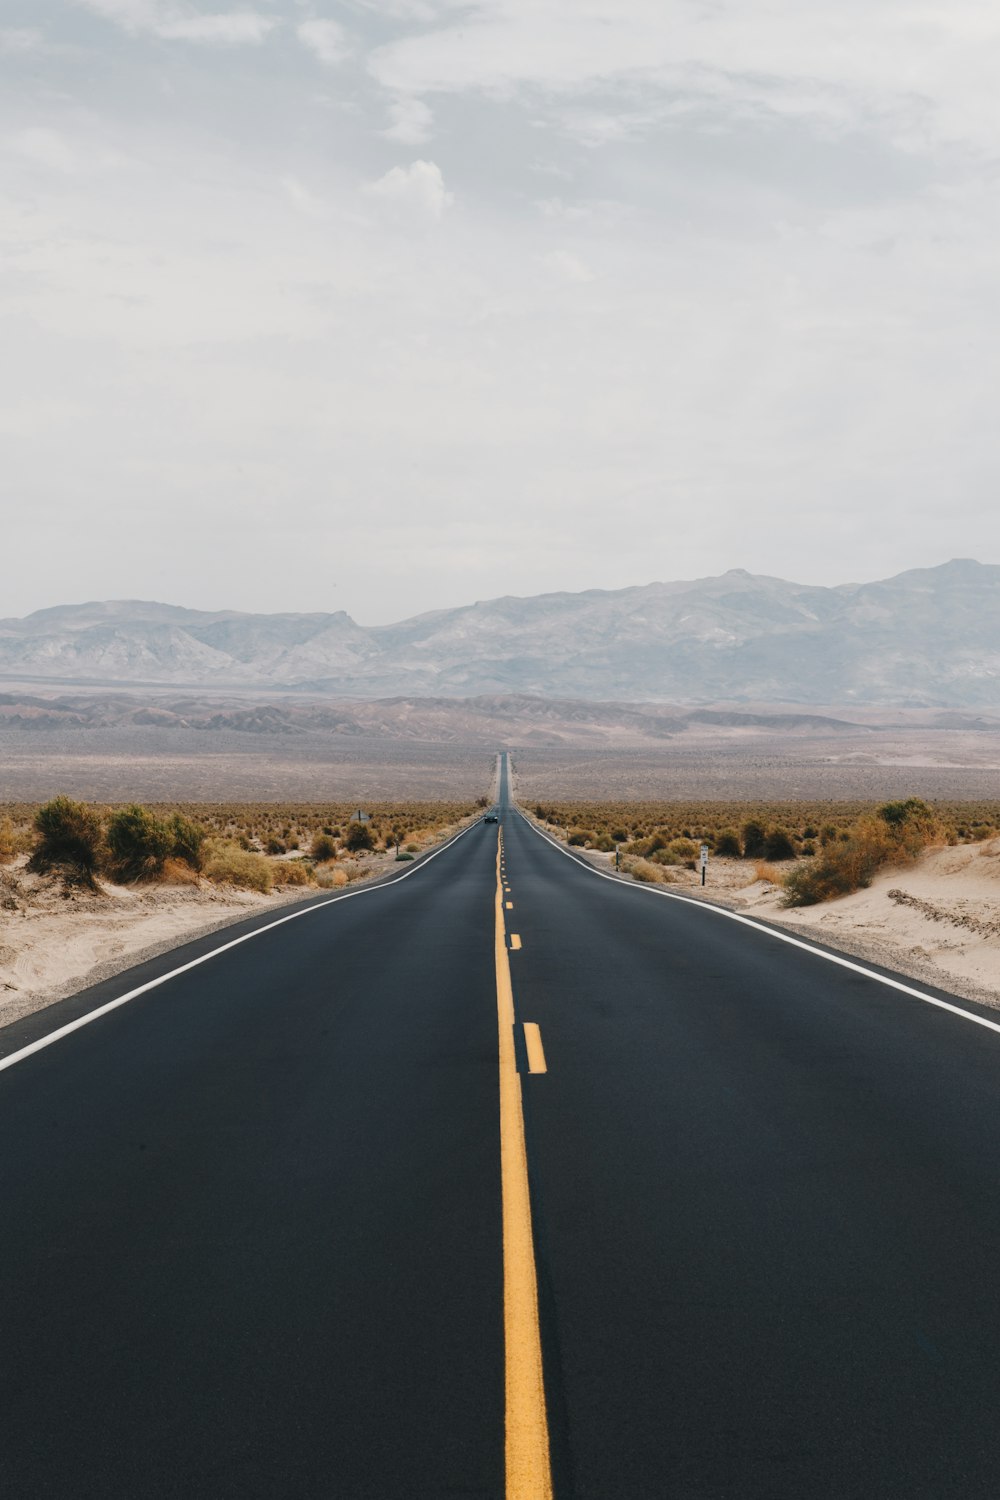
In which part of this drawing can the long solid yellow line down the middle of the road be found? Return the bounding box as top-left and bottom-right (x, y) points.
(495, 834), (552, 1500)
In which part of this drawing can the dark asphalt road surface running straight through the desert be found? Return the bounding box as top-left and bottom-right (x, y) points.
(0, 756), (1000, 1500)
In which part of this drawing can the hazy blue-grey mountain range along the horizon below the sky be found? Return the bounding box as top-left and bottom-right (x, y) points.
(0, 561), (1000, 710)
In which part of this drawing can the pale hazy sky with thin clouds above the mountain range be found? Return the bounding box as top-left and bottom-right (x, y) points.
(0, 0), (1000, 624)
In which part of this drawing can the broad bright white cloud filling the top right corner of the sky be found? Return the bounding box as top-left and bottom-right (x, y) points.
(369, 0), (1000, 150)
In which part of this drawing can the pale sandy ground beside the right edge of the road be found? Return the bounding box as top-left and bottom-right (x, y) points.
(539, 839), (1000, 1010)
